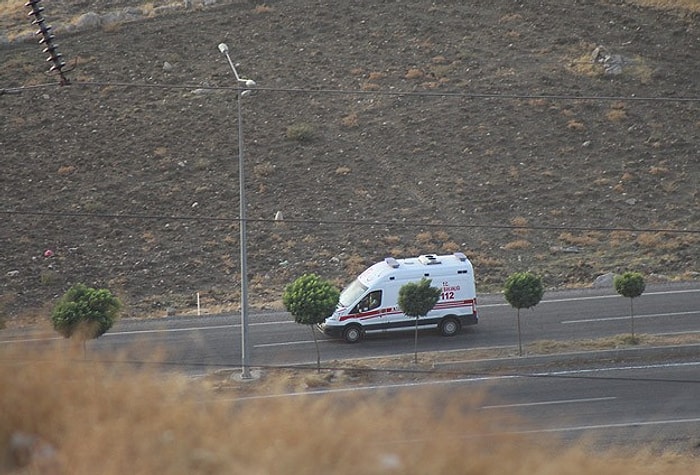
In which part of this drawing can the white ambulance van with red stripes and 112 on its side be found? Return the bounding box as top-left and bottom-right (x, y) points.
(319, 252), (479, 343)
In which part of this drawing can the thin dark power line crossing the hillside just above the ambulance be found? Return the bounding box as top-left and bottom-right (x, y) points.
(0, 210), (700, 234)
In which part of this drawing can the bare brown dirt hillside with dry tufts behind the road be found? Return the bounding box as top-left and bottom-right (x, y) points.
(0, 0), (700, 324)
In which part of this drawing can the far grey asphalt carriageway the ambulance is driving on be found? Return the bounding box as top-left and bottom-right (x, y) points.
(76, 284), (700, 370)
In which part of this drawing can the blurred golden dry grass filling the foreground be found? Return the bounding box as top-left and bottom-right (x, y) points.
(0, 350), (700, 475)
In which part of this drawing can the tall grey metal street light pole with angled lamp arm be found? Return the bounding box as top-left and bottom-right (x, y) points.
(219, 43), (255, 379)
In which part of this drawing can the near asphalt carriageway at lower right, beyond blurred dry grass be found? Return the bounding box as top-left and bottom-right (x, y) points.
(470, 361), (700, 453)
